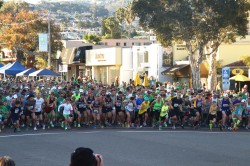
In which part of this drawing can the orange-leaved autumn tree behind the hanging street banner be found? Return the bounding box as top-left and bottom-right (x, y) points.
(0, 3), (63, 65)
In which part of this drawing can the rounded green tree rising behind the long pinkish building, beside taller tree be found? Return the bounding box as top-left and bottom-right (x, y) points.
(102, 17), (121, 39)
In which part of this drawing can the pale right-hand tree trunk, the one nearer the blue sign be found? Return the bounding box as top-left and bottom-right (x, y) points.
(207, 53), (217, 90)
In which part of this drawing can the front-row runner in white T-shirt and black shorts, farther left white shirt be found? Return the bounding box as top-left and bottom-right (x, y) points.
(34, 93), (45, 130)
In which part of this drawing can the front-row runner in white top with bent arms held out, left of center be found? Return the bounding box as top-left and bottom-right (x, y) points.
(58, 98), (73, 130)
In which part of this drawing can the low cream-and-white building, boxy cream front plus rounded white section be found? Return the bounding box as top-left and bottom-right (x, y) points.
(86, 44), (171, 84)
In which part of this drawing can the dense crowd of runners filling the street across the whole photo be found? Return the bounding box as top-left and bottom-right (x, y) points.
(0, 80), (250, 132)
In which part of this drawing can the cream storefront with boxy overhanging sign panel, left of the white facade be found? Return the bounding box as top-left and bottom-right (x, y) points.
(86, 47), (122, 84)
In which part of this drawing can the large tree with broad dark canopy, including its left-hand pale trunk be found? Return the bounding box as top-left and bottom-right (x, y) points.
(132, 0), (249, 89)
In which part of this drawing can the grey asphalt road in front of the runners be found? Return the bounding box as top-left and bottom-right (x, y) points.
(0, 129), (250, 166)
